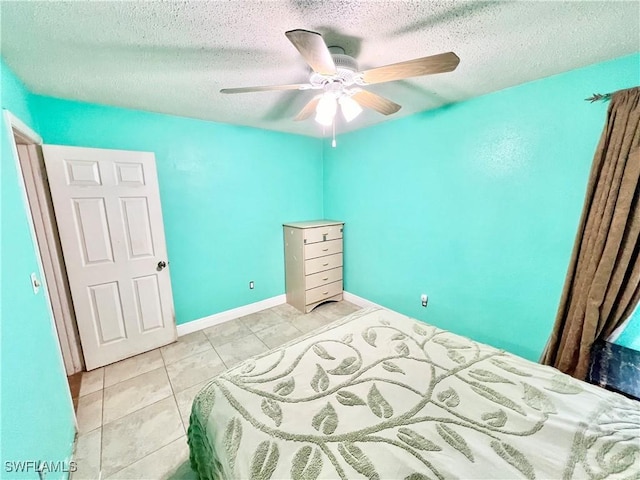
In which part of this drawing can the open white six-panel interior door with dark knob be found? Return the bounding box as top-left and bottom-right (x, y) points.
(43, 145), (176, 370)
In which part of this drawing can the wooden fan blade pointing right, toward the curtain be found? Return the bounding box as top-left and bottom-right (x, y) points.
(362, 52), (460, 83)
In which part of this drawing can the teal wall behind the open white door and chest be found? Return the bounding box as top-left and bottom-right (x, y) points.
(32, 96), (322, 324)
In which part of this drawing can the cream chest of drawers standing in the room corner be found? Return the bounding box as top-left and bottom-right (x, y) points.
(283, 220), (344, 313)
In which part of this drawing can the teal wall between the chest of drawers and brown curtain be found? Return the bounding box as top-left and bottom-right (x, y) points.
(324, 55), (640, 360)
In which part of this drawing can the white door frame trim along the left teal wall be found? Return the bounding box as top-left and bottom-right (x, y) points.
(3, 109), (78, 424)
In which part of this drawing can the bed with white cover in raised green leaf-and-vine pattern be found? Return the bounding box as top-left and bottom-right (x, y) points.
(188, 308), (640, 480)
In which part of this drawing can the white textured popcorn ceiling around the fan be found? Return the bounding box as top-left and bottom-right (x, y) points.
(0, 0), (640, 136)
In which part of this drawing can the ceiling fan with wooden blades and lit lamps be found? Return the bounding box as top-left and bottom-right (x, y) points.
(220, 29), (460, 126)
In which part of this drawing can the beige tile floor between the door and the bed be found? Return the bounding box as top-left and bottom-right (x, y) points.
(72, 301), (359, 480)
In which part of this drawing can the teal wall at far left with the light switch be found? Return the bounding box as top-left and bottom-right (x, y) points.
(0, 61), (75, 479)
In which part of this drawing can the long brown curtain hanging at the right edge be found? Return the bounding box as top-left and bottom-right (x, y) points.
(541, 87), (640, 379)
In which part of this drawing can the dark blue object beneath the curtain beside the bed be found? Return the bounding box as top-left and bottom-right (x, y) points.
(587, 341), (640, 400)
